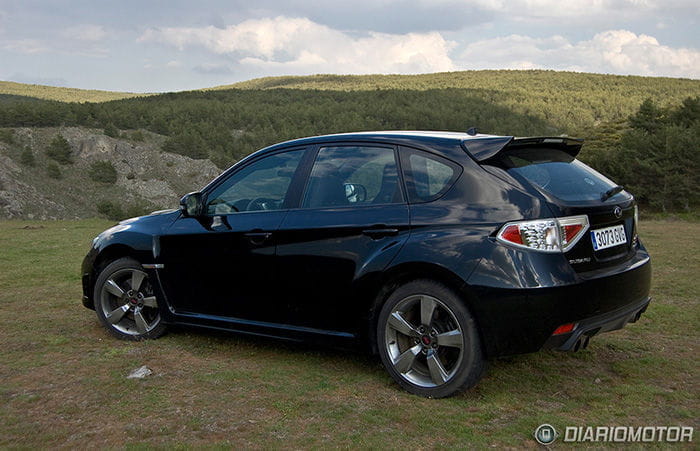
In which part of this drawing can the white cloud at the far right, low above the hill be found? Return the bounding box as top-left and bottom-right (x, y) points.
(458, 30), (700, 78)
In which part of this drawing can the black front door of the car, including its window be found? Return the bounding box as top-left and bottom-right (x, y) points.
(160, 149), (305, 320)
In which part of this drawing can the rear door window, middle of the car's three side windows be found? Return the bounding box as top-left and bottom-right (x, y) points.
(302, 146), (403, 208)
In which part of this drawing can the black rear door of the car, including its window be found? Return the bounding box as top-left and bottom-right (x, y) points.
(276, 144), (409, 333)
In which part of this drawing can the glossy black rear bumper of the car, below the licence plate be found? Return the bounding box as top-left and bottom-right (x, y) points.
(470, 249), (651, 357)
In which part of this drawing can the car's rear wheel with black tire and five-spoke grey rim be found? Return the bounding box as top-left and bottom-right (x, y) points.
(376, 280), (484, 398)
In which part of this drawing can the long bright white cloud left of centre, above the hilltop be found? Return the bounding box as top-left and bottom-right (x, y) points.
(139, 17), (455, 74)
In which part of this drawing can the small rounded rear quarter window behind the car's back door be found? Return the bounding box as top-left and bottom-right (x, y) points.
(406, 151), (461, 203)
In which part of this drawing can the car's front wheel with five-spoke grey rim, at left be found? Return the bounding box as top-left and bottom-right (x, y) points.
(93, 257), (166, 340)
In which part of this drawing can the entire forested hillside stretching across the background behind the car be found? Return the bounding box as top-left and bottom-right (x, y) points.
(0, 71), (700, 217)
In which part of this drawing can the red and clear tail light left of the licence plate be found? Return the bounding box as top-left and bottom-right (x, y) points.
(496, 215), (588, 252)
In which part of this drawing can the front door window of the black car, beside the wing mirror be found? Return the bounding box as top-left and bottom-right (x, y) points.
(207, 149), (304, 215)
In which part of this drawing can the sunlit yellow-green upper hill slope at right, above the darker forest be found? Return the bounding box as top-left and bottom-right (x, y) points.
(224, 70), (700, 130)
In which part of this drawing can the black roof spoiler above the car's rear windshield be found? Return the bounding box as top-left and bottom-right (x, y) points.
(462, 136), (583, 162)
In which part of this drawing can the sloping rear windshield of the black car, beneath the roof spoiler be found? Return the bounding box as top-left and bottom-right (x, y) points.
(498, 147), (620, 201)
